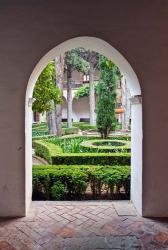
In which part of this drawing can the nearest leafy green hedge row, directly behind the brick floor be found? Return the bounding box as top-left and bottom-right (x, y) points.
(33, 165), (130, 200)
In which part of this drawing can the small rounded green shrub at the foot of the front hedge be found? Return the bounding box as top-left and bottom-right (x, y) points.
(51, 181), (65, 200)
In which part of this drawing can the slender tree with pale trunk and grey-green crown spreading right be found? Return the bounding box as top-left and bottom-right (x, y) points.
(65, 49), (89, 128)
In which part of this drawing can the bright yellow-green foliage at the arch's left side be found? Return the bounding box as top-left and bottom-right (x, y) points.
(32, 62), (62, 113)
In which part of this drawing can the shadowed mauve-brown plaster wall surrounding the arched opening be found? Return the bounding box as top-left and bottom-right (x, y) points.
(0, 0), (168, 216)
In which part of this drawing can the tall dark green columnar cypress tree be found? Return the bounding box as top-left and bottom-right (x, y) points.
(96, 56), (117, 139)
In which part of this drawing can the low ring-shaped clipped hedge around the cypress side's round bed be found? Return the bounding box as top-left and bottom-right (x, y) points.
(80, 139), (131, 153)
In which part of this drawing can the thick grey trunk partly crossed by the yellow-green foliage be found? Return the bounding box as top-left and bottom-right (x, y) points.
(55, 56), (64, 136)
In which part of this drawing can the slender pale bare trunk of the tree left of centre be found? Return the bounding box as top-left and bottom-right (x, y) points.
(67, 66), (72, 128)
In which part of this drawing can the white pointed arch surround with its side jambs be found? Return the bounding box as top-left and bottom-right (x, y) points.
(25, 37), (142, 214)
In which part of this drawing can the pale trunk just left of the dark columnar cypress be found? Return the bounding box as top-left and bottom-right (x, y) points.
(89, 63), (96, 125)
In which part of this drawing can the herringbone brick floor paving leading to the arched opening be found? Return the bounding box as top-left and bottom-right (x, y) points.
(0, 201), (168, 250)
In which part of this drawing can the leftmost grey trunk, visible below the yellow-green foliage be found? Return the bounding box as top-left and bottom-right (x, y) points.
(46, 102), (57, 135)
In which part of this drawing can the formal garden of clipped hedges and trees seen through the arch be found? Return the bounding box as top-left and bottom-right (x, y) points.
(32, 50), (131, 200)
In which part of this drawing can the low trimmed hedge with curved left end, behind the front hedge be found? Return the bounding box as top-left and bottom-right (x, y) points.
(33, 140), (130, 165)
